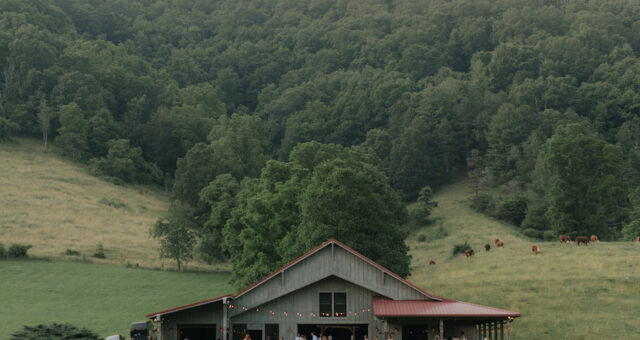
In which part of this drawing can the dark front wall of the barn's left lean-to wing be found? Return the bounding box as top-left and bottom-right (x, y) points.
(162, 301), (223, 340)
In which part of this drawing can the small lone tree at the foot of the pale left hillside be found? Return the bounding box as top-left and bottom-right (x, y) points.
(150, 201), (195, 271)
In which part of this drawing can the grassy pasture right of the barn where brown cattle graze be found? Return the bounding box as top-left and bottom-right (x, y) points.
(408, 182), (640, 339)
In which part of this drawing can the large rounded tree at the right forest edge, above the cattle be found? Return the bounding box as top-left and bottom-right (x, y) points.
(543, 124), (627, 239)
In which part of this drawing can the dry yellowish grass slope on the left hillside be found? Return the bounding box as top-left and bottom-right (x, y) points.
(0, 139), (228, 270)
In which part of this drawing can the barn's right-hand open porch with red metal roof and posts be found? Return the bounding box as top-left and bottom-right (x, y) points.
(373, 298), (520, 340)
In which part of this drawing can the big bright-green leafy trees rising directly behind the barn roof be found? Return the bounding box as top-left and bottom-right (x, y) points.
(222, 142), (409, 287)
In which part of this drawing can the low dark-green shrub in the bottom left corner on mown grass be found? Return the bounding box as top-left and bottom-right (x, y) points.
(11, 323), (101, 340)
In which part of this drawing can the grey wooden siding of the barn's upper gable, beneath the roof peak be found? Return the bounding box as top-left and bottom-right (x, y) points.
(231, 245), (427, 316)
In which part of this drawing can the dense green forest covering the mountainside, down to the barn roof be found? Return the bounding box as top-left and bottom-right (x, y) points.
(0, 0), (640, 285)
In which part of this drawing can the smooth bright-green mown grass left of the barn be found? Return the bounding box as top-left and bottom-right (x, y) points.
(0, 260), (231, 339)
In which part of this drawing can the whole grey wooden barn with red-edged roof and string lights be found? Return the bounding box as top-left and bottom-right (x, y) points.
(147, 239), (521, 340)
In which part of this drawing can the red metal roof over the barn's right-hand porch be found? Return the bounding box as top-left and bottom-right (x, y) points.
(373, 298), (522, 319)
